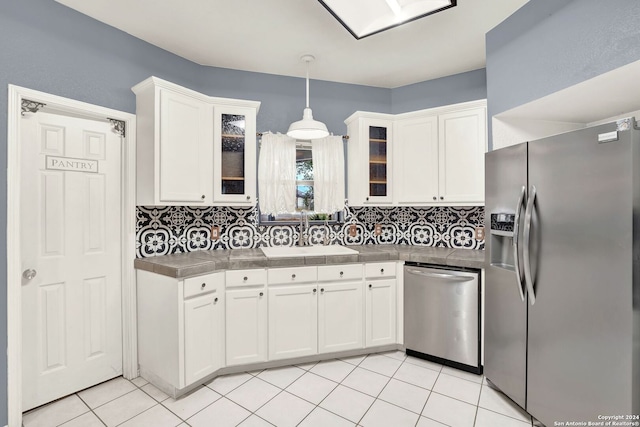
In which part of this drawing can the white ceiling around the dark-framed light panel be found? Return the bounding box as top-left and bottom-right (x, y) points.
(56, 0), (528, 88)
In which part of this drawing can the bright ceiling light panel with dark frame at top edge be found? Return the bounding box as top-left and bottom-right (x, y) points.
(318, 0), (456, 40)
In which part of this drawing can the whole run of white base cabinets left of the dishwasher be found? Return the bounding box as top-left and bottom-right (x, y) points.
(137, 262), (397, 397)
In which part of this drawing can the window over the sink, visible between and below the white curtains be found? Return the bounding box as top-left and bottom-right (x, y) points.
(260, 141), (342, 224)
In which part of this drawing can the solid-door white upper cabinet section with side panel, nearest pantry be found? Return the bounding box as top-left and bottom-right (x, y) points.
(133, 77), (213, 205)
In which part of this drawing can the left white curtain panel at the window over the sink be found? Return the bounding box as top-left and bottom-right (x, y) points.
(258, 133), (296, 215)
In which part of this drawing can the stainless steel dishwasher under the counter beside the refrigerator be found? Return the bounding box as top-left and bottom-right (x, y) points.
(404, 263), (482, 374)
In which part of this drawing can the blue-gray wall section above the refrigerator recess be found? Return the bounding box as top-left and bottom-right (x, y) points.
(486, 0), (640, 144)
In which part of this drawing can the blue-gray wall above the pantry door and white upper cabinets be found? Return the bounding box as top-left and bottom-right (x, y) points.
(0, 0), (485, 425)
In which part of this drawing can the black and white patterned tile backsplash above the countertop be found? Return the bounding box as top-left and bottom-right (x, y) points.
(136, 206), (484, 258)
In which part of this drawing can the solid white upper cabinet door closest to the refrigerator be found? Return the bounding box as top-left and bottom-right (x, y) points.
(438, 107), (487, 203)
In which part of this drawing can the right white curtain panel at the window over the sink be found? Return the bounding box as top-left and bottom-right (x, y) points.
(311, 136), (344, 214)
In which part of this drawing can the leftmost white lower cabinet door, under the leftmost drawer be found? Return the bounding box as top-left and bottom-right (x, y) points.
(184, 292), (224, 386)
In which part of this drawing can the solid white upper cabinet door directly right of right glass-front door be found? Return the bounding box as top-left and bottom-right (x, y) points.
(393, 116), (438, 205)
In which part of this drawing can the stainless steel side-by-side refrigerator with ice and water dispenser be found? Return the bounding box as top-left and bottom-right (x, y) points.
(485, 119), (640, 427)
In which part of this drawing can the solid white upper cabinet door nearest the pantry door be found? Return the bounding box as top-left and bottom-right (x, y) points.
(159, 89), (213, 204)
